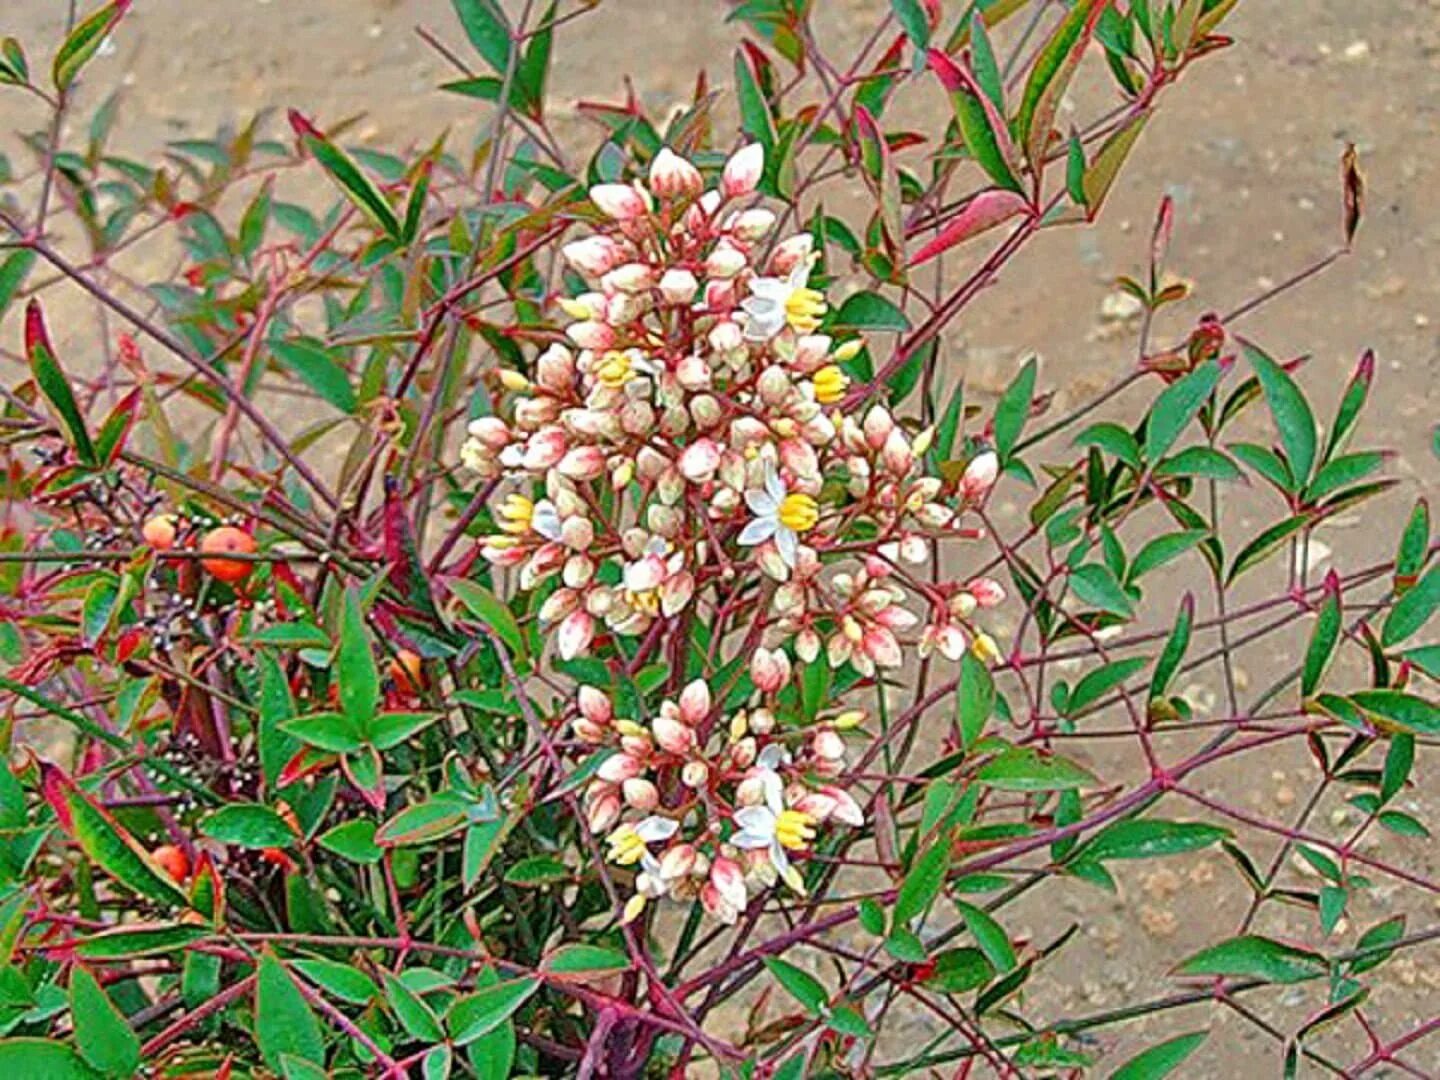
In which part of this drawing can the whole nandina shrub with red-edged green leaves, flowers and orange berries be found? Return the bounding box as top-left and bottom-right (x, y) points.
(0, 0), (1440, 1077)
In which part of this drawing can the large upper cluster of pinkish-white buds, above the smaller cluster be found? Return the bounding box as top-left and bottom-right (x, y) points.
(462, 145), (996, 671)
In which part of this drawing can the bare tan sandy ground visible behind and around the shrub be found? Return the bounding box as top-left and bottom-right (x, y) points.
(0, 0), (1440, 1077)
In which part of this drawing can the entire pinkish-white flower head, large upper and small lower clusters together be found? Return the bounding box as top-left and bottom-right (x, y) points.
(462, 145), (1004, 919)
